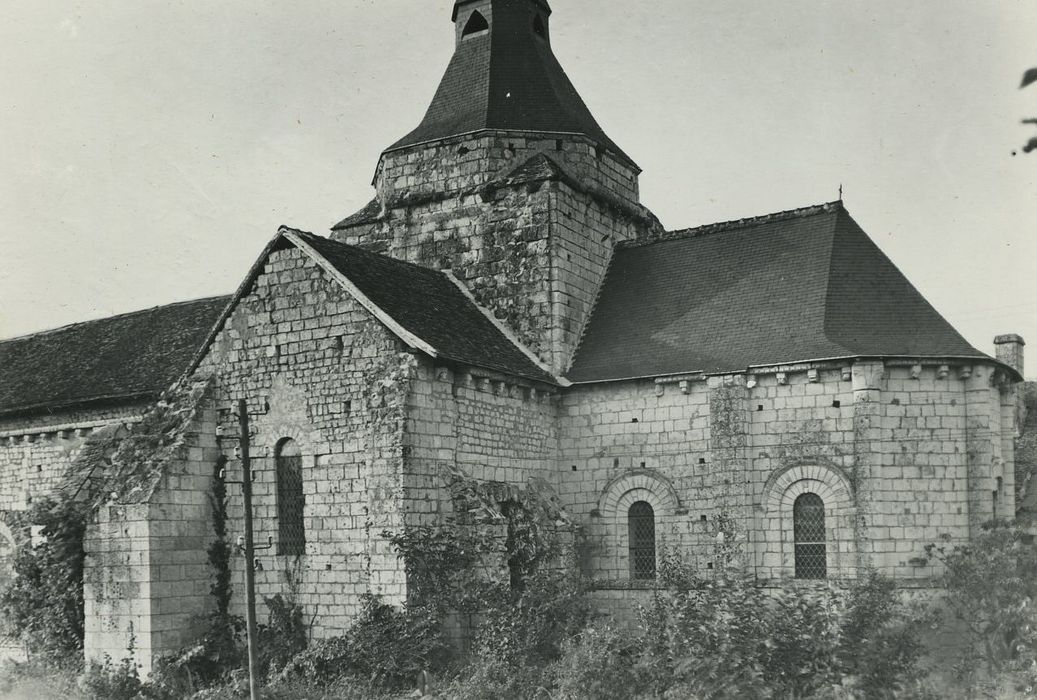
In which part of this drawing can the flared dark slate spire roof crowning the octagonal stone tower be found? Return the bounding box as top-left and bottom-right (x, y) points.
(387, 0), (637, 167)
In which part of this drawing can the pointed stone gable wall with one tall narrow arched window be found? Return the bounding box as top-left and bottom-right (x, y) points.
(195, 243), (415, 638)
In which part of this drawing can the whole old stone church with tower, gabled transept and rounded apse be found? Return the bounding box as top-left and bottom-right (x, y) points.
(0, 0), (1024, 667)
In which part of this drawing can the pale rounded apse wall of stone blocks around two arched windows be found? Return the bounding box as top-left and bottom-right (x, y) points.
(558, 362), (1015, 587)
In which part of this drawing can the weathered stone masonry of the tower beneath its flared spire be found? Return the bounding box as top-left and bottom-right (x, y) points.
(335, 134), (646, 371)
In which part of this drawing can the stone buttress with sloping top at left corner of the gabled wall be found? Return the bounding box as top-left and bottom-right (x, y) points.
(83, 400), (220, 674)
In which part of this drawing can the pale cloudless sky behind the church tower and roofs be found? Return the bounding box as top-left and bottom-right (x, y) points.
(0, 0), (1037, 375)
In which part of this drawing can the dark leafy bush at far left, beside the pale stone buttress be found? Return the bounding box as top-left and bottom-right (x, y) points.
(0, 497), (87, 665)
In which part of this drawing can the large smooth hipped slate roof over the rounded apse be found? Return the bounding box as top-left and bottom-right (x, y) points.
(566, 202), (989, 383)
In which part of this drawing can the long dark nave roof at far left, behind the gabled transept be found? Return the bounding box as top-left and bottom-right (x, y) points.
(0, 297), (230, 416)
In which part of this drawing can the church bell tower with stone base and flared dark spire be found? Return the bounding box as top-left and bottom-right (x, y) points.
(333, 0), (660, 373)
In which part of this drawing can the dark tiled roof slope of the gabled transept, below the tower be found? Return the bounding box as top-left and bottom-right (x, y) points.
(290, 231), (557, 384)
